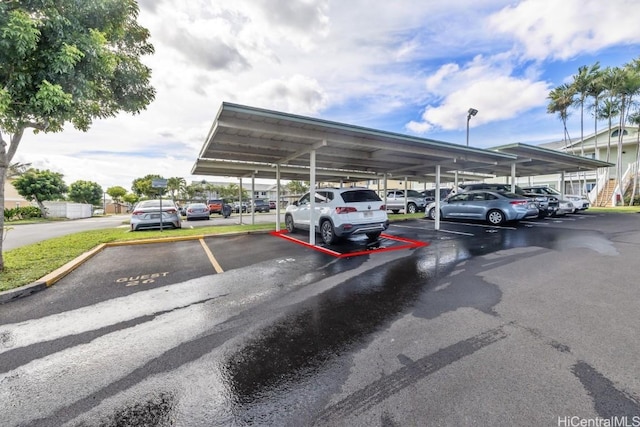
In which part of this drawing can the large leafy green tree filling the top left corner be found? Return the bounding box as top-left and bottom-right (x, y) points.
(0, 0), (155, 270)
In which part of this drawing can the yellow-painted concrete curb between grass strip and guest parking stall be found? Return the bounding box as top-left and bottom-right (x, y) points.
(0, 230), (273, 304)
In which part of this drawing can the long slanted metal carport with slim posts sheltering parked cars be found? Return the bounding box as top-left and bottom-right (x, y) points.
(191, 102), (608, 244)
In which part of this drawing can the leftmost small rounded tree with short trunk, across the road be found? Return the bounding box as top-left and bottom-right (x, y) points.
(12, 169), (67, 218)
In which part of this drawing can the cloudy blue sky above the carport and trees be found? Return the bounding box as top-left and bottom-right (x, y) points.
(13, 0), (640, 190)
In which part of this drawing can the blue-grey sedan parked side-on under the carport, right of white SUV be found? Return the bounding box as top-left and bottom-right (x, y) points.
(427, 190), (538, 225)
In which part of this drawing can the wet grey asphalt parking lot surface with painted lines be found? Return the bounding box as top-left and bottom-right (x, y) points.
(0, 213), (640, 426)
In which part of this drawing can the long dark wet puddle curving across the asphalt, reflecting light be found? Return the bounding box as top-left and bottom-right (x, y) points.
(225, 228), (615, 418)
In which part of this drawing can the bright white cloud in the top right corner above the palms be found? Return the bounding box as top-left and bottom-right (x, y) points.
(489, 0), (640, 60)
